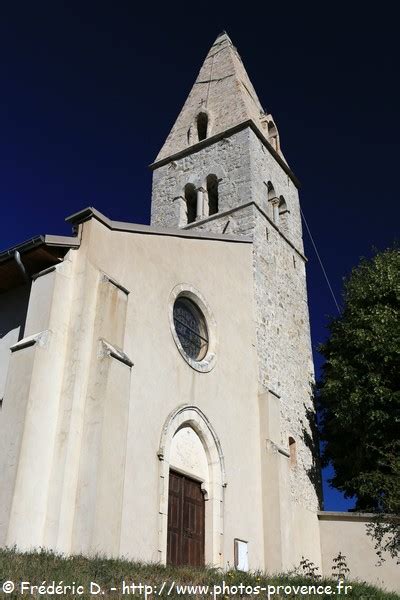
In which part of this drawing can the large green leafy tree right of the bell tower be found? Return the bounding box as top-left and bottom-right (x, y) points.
(318, 247), (400, 558)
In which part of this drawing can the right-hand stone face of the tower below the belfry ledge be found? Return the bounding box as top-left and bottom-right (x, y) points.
(253, 211), (318, 510)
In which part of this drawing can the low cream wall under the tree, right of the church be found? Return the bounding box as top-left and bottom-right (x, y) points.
(318, 512), (400, 592)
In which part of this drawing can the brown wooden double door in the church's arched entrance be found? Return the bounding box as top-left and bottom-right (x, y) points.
(167, 471), (205, 566)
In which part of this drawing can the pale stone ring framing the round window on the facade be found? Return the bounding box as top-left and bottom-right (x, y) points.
(168, 283), (217, 373)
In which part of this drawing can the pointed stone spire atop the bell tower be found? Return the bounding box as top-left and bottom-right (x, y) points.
(156, 31), (279, 162)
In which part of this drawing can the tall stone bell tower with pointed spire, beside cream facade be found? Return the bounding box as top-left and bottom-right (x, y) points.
(151, 33), (320, 570)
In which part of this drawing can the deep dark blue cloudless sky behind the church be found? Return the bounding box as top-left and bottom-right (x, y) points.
(0, 0), (400, 509)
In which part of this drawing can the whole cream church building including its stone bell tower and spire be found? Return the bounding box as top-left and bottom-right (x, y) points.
(0, 33), (395, 583)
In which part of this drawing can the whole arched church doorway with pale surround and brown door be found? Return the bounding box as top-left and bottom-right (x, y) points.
(158, 405), (226, 567)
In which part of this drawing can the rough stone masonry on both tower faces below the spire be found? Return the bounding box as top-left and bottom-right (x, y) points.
(152, 129), (318, 511)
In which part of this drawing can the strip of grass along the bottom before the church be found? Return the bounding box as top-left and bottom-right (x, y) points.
(0, 549), (400, 600)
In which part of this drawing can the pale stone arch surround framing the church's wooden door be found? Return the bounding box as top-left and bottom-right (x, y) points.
(158, 404), (227, 567)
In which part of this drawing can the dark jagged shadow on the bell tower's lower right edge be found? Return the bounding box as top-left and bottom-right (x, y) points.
(300, 382), (323, 509)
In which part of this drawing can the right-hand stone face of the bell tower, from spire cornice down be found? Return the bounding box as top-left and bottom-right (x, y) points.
(249, 127), (318, 510)
